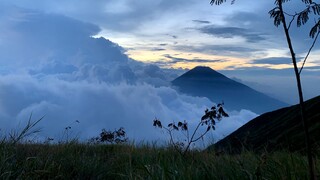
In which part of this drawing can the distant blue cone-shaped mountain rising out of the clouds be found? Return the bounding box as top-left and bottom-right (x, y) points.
(172, 66), (288, 114)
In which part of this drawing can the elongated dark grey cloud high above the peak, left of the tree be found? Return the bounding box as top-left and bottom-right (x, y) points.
(199, 25), (266, 43)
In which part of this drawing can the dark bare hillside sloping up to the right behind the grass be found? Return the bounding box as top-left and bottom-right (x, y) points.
(210, 96), (320, 152)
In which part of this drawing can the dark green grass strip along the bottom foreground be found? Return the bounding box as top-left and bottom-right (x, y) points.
(0, 142), (320, 179)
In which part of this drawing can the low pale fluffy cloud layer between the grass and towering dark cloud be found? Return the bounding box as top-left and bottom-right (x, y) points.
(0, 75), (257, 145)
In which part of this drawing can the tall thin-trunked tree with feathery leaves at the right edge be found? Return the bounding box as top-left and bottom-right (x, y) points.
(210, 0), (320, 179)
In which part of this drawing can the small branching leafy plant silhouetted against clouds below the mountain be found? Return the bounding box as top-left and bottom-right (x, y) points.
(153, 104), (229, 156)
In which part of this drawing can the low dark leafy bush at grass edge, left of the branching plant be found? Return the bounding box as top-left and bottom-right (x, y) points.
(90, 127), (128, 144)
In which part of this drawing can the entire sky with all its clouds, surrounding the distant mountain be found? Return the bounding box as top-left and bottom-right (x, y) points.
(0, 0), (320, 145)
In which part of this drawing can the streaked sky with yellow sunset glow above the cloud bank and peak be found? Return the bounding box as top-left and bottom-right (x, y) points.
(4, 0), (320, 70)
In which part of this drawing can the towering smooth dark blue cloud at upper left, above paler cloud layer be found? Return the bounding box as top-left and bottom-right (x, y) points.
(0, 6), (128, 68)
